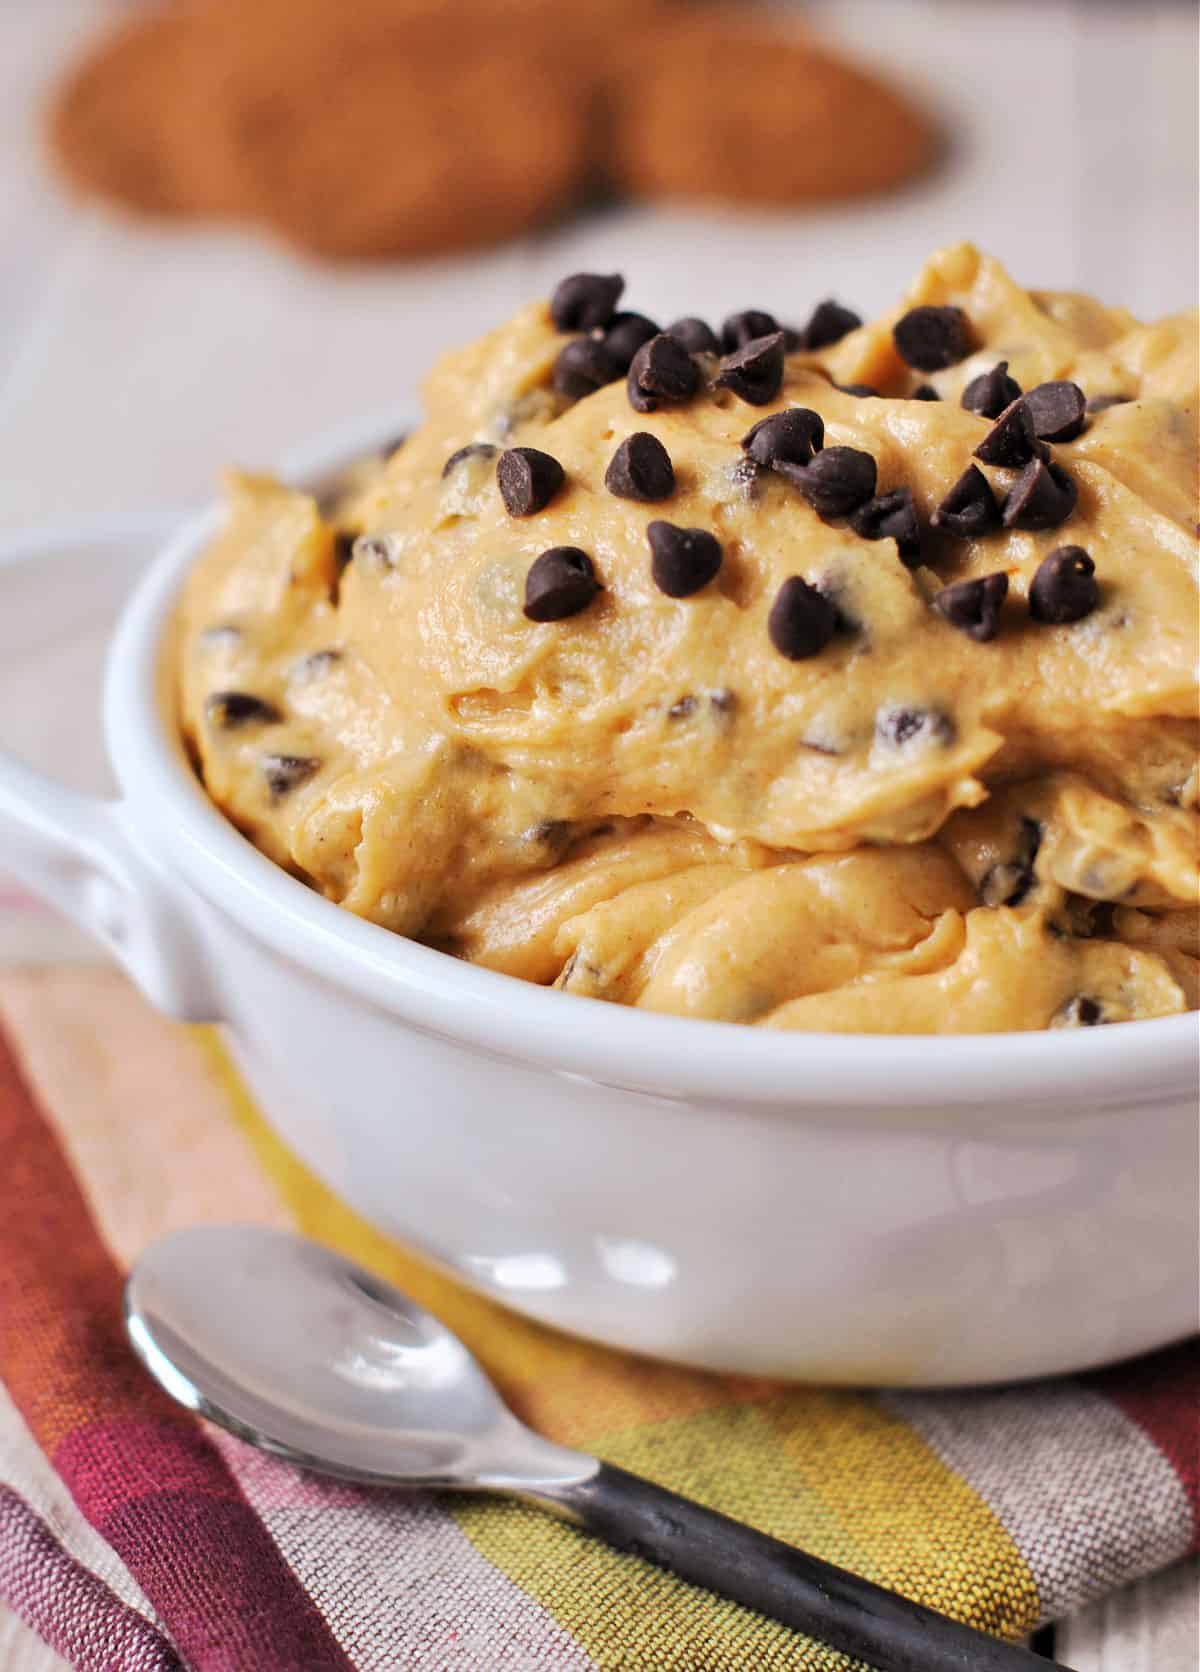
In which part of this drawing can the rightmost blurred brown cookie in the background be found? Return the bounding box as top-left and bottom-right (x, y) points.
(610, 21), (936, 206)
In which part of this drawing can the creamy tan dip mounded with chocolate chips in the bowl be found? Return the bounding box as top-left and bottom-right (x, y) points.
(179, 246), (1200, 1032)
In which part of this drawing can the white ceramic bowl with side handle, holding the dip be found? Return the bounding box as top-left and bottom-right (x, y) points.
(0, 428), (1200, 1384)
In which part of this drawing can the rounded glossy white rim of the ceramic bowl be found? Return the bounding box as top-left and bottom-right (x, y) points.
(104, 413), (1200, 1112)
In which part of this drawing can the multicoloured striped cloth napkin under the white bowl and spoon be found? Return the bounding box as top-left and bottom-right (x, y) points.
(0, 968), (1200, 1672)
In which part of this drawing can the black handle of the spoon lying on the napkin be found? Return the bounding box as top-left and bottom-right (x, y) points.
(536, 1463), (1070, 1672)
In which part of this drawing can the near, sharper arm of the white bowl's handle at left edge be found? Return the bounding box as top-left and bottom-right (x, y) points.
(0, 752), (221, 1022)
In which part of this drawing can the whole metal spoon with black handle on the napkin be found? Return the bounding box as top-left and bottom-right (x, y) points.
(125, 1226), (1055, 1672)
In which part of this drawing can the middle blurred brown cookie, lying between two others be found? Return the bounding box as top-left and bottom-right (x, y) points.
(220, 15), (590, 259)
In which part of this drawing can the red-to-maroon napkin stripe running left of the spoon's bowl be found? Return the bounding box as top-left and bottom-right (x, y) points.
(0, 1032), (351, 1672)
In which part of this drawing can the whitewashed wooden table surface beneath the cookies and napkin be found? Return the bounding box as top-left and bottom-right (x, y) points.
(0, 0), (1200, 1672)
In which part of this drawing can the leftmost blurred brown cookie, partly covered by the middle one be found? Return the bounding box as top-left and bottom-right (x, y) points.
(48, 7), (246, 217)
